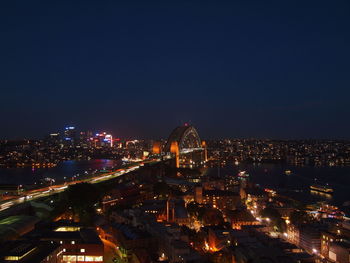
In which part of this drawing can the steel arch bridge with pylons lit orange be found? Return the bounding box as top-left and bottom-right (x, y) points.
(159, 125), (207, 168)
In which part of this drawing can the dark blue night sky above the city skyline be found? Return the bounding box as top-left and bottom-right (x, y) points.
(0, 0), (350, 139)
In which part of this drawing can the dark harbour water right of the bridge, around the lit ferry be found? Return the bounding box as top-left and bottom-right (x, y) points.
(209, 164), (350, 206)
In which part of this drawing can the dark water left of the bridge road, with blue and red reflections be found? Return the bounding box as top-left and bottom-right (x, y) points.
(0, 159), (122, 185)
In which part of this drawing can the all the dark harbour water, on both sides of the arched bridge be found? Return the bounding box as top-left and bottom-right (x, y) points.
(0, 159), (350, 209)
